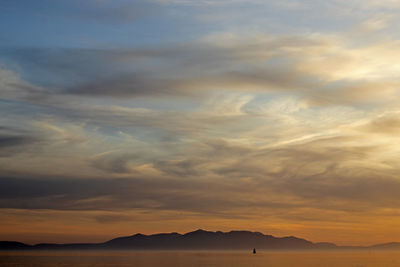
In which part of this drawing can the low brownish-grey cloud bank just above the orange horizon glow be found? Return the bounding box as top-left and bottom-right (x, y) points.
(0, 130), (400, 219)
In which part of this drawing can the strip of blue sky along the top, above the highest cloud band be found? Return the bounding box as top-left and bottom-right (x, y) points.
(0, 0), (385, 48)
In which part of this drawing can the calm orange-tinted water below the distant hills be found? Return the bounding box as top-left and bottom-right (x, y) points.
(0, 251), (400, 267)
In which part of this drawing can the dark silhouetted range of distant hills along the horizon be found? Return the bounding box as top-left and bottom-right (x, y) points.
(0, 229), (400, 250)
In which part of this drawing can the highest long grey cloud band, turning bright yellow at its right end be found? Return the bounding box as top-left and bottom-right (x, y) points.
(3, 31), (399, 111)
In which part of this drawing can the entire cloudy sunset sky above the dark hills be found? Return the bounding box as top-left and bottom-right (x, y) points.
(0, 0), (400, 245)
